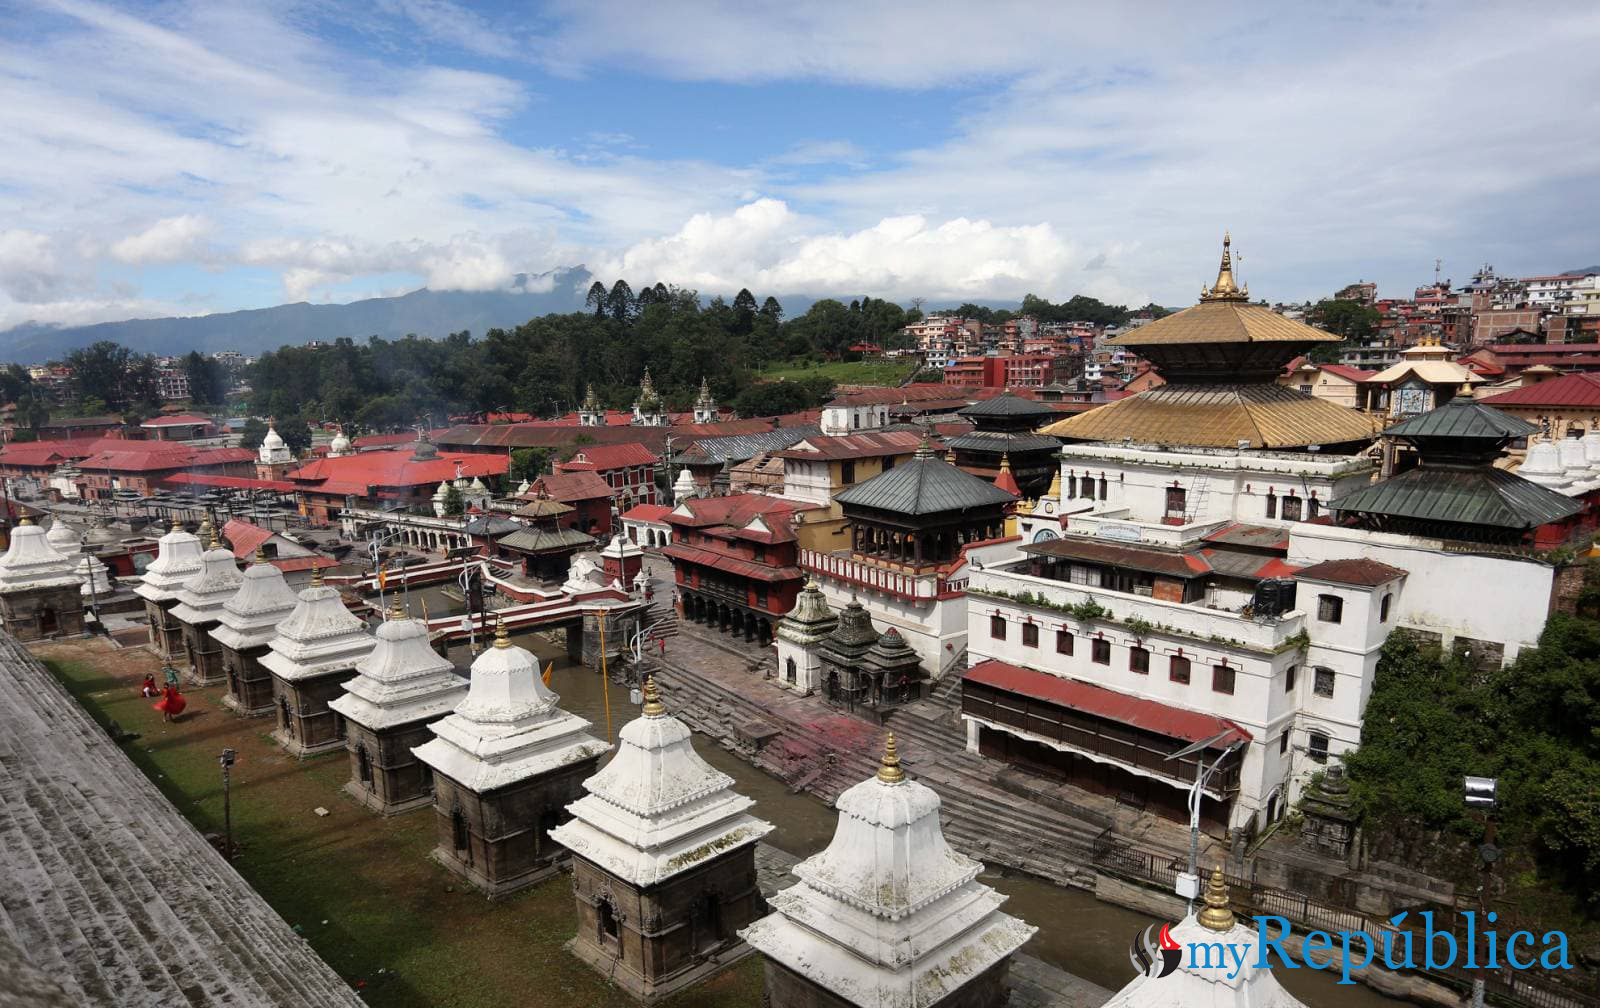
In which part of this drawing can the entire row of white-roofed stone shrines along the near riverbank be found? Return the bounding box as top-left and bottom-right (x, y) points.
(0, 525), (1299, 1008)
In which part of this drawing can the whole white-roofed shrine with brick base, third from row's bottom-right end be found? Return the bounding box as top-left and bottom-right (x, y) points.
(550, 678), (773, 1003)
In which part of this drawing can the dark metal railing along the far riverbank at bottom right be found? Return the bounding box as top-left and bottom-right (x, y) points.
(1093, 829), (1600, 1008)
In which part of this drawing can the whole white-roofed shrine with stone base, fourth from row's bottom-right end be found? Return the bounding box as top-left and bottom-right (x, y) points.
(414, 626), (611, 898)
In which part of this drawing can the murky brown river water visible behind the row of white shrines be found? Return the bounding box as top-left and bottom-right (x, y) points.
(428, 627), (1410, 1008)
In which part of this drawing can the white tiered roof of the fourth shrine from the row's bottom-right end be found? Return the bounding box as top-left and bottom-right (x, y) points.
(413, 626), (611, 794)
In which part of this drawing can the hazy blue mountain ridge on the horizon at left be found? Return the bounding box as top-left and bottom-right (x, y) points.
(0, 267), (589, 363)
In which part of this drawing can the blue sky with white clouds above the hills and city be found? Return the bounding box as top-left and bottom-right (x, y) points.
(0, 0), (1600, 328)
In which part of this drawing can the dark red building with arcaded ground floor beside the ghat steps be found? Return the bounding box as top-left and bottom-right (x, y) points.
(661, 493), (806, 646)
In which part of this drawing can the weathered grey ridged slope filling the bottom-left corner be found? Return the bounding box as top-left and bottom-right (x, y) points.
(0, 635), (362, 1008)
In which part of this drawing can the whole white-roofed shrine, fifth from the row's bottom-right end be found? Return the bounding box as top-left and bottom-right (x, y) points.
(328, 603), (467, 816)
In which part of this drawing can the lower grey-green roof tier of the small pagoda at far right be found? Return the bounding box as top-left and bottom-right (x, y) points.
(1328, 466), (1582, 530)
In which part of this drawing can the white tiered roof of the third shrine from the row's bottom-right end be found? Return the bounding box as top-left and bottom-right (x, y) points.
(550, 678), (773, 888)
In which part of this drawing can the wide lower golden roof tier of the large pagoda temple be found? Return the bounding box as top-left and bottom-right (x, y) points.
(1040, 384), (1376, 448)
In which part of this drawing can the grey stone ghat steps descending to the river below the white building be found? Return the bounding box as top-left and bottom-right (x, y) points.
(658, 656), (1102, 885)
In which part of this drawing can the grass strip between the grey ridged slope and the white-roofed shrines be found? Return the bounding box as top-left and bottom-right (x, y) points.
(40, 642), (762, 1008)
